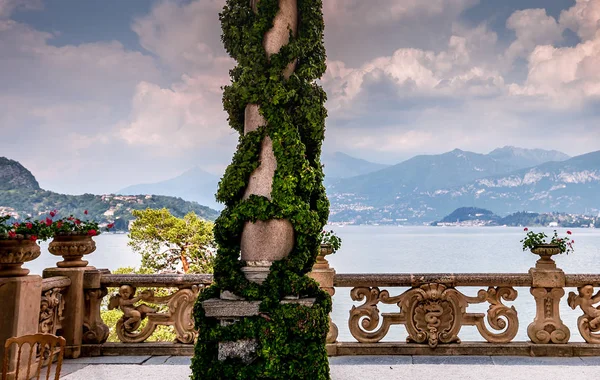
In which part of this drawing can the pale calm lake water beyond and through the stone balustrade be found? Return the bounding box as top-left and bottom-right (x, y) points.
(30, 226), (600, 342)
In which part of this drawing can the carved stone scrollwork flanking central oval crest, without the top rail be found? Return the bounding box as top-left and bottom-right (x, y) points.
(348, 283), (519, 348)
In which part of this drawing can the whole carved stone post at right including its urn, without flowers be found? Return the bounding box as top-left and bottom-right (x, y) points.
(527, 247), (571, 344)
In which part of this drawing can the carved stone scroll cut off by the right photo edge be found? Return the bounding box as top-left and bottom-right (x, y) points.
(568, 285), (600, 344)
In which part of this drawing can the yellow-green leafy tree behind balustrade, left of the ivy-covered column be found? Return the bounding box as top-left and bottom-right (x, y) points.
(128, 208), (215, 273)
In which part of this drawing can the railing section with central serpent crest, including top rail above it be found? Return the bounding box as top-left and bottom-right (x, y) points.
(335, 274), (520, 348)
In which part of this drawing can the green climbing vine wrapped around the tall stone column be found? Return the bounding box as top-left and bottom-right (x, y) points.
(192, 0), (331, 379)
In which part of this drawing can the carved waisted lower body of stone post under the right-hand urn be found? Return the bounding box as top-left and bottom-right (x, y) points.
(527, 288), (571, 344)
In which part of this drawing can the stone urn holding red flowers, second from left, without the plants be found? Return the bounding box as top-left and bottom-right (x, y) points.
(48, 235), (96, 268)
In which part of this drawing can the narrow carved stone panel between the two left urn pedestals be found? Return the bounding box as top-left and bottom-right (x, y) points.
(38, 276), (71, 335)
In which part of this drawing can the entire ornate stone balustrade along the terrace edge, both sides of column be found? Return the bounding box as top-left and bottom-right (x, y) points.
(5, 243), (600, 357)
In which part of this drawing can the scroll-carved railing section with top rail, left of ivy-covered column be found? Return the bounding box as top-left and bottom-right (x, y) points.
(100, 274), (212, 344)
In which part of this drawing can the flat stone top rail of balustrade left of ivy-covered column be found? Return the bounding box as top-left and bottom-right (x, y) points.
(100, 274), (213, 288)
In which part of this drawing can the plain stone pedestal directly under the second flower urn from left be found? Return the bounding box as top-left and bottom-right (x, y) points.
(43, 267), (90, 359)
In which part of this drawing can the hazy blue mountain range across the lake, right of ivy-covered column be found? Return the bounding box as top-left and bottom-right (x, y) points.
(328, 148), (600, 223)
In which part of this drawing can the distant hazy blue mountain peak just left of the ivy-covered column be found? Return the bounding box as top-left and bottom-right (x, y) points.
(117, 167), (223, 210)
